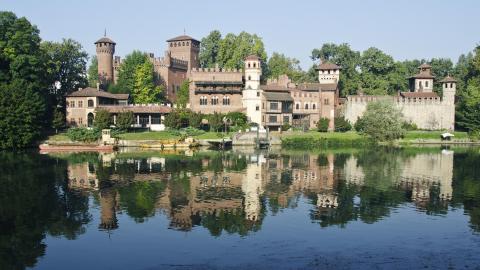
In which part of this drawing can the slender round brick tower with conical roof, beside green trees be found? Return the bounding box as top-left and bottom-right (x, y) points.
(95, 36), (116, 85)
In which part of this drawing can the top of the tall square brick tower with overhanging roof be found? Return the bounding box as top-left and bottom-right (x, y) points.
(167, 35), (200, 70)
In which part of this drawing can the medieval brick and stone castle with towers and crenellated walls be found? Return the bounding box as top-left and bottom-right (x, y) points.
(91, 35), (456, 130)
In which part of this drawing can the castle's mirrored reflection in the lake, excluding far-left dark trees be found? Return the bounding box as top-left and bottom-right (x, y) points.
(62, 149), (464, 235)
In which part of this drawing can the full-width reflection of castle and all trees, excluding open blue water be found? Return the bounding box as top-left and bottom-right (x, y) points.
(0, 149), (480, 269)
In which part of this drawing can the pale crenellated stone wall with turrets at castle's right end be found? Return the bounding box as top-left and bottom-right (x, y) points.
(343, 64), (456, 130)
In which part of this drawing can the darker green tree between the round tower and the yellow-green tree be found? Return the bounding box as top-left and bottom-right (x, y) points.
(114, 51), (148, 94)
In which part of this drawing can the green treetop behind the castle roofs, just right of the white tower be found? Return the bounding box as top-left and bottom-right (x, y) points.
(265, 52), (303, 82)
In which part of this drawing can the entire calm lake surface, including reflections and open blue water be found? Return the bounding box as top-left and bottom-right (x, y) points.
(0, 148), (480, 269)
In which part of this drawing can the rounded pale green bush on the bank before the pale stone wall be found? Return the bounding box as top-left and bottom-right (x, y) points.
(361, 101), (405, 142)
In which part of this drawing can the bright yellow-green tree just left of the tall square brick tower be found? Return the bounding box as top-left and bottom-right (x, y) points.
(132, 61), (163, 104)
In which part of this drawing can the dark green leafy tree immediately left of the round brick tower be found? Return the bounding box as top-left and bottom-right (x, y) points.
(40, 39), (88, 107)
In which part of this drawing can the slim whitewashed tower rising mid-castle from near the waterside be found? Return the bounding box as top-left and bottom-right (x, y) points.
(242, 55), (262, 125)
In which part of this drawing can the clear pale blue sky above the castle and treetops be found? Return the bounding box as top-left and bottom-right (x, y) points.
(0, 0), (480, 69)
